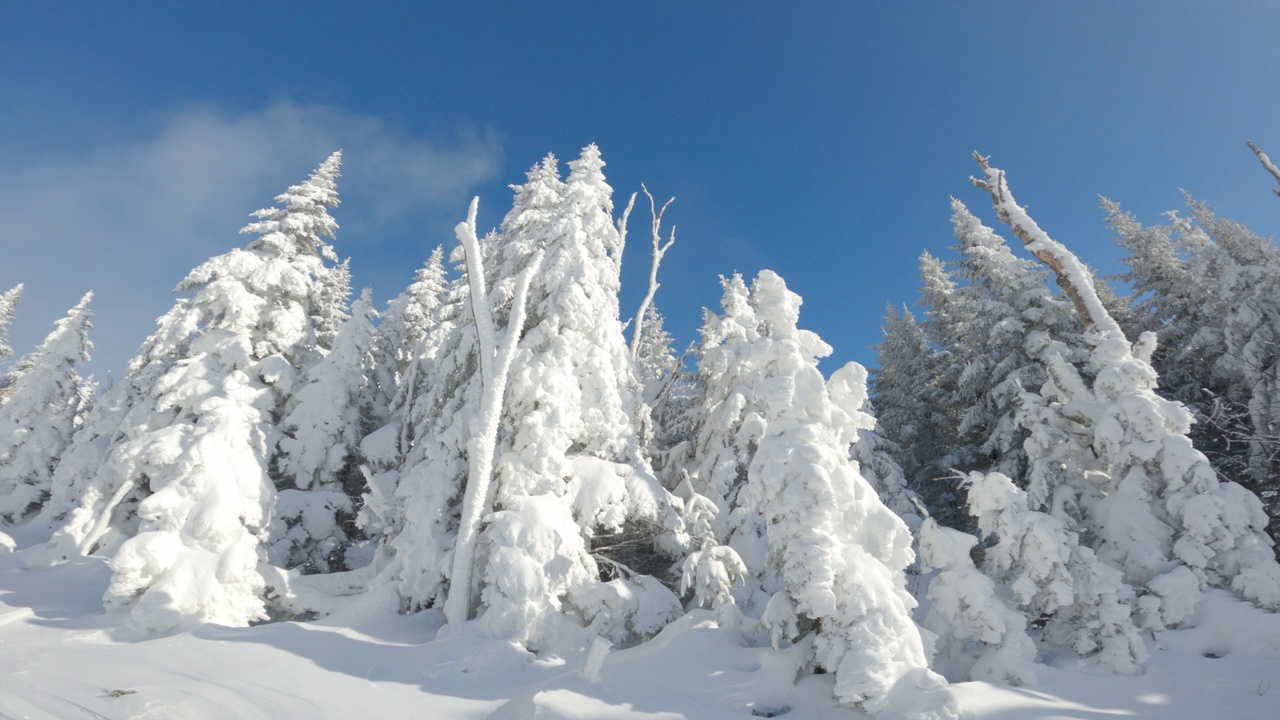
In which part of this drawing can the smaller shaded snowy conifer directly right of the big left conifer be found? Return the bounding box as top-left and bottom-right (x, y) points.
(275, 290), (378, 573)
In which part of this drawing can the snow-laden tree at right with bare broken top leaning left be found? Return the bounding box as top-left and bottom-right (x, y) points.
(974, 158), (1280, 626)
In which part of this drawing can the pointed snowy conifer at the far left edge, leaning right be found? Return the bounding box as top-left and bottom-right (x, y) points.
(0, 287), (93, 524)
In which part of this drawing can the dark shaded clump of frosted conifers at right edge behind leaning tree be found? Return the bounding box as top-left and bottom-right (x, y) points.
(1103, 202), (1280, 535)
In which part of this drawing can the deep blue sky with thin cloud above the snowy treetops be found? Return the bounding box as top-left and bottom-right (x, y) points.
(0, 0), (1280, 378)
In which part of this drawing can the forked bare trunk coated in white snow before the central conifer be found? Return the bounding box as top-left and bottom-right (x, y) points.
(444, 240), (543, 624)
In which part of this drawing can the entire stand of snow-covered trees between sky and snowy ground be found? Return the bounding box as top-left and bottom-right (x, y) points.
(0, 145), (1280, 717)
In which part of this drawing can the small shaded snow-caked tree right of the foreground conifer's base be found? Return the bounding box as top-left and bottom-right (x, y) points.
(920, 518), (1036, 685)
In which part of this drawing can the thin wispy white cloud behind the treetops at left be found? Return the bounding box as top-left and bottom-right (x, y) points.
(0, 101), (502, 379)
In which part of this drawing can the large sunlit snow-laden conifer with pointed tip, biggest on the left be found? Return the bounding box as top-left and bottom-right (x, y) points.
(40, 152), (340, 632)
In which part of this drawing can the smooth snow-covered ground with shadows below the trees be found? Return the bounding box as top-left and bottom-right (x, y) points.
(0, 535), (1280, 720)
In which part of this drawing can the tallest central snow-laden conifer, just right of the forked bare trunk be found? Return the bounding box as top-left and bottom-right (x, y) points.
(481, 145), (678, 646)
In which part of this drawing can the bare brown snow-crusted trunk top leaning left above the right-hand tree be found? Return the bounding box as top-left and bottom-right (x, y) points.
(969, 152), (1124, 338)
